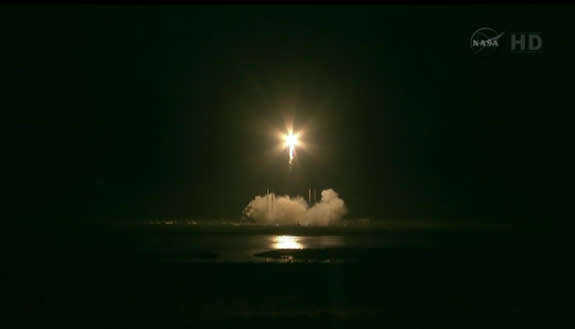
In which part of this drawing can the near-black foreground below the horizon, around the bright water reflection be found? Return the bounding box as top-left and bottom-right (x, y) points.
(2, 222), (575, 328)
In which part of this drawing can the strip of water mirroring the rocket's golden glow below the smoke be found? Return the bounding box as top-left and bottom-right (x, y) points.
(130, 226), (552, 262)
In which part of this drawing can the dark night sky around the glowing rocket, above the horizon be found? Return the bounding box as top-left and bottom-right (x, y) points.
(0, 5), (575, 221)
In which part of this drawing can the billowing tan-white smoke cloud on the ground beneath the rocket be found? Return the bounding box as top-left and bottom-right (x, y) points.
(244, 189), (347, 226)
